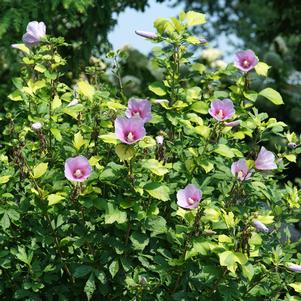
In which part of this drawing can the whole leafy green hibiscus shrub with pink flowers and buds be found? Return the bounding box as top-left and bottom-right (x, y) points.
(0, 11), (301, 301)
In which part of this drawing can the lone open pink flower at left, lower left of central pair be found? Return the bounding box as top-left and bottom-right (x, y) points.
(65, 156), (92, 182)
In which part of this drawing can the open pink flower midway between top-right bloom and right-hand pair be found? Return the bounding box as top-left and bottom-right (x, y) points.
(208, 98), (235, 121)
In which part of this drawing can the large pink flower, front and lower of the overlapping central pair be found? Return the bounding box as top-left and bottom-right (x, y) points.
(115, 117), (146, 144)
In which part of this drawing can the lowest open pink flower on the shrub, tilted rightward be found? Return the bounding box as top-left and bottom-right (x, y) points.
(177, 184), (202, 209)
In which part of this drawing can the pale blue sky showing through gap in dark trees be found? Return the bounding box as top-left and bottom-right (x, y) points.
(109, 0), (235, 62)
